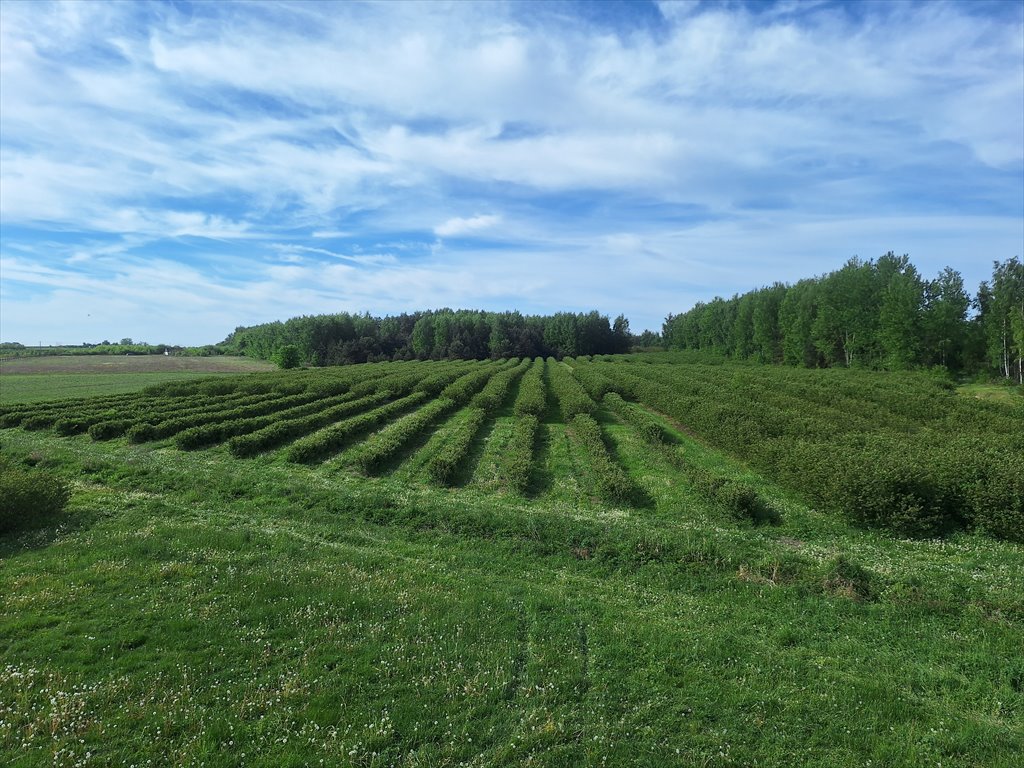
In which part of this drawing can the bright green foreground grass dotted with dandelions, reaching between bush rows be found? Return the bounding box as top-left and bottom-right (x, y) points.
(0, 367), (1024, 768)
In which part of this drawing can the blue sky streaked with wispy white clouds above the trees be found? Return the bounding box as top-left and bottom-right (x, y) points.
(0, 0), (1024, 345)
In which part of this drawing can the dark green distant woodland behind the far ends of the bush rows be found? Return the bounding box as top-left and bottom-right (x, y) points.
(218, 309), (633, 366)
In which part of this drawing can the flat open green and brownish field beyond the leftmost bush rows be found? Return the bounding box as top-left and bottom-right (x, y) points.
(0, 355), (273, 404)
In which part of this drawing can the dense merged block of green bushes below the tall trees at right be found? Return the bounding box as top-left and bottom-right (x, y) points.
(599, 364), (1024, 540)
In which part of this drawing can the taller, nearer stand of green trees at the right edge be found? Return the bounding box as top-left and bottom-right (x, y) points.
(663, 256), (1024, 383)
